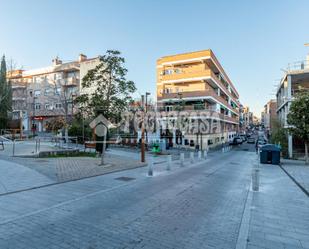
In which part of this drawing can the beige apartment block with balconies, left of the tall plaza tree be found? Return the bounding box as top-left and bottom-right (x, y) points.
(8, 54), (100, 132)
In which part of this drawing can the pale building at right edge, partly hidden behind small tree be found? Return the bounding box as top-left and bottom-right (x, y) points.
(276, 55), (309, 158)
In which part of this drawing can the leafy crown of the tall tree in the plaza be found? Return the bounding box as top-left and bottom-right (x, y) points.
(76, 50), (136, 121)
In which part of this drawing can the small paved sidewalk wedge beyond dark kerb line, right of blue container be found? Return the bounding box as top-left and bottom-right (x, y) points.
(282, 160), (309, 192)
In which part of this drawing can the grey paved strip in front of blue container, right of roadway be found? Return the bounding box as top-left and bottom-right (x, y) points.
(247, 165), (309, 249)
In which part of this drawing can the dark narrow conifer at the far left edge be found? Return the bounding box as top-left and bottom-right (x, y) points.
(0, 55), (12, 129)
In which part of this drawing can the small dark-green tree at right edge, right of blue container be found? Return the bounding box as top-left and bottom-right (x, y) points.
(287, 92), (309, 164)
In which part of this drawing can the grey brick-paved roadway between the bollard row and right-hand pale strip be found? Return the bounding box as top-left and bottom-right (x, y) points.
(0, 144), (256, 249)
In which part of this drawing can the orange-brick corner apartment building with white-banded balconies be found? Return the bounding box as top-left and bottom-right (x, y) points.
(157, 49), (240, 148)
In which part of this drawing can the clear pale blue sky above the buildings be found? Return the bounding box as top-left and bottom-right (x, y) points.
(0, 0), (309, 115)
